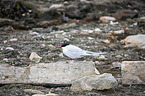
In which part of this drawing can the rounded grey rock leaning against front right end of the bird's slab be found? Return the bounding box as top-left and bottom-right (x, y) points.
(71, 73), (118, 91)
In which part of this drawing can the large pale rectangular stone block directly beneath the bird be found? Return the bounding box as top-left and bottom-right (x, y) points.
(29, 61), (96, 84)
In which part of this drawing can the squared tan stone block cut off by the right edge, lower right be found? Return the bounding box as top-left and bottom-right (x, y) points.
(121, 61), (145, 85)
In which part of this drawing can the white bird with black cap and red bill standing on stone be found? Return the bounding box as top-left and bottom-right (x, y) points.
(58, 43), (107, 60)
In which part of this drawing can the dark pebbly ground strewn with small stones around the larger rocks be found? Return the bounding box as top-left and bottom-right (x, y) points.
(0, 0), (145, 96)
